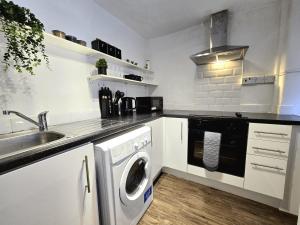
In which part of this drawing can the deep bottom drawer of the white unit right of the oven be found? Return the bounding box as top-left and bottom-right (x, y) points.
(244, 155), (287, 199)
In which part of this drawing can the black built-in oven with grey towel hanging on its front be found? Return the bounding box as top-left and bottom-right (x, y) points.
(188, 117), (249, 177)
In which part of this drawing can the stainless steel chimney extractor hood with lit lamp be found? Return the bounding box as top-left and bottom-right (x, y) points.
(190, 10), (249, 65)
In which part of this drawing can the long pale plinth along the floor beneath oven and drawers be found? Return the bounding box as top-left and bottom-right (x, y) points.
(162, 167), (289, 213)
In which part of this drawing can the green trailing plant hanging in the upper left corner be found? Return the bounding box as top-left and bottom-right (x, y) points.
(0, 0), (49, 75)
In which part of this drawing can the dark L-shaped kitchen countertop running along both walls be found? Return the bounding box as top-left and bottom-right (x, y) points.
(0, 110), (300, 173)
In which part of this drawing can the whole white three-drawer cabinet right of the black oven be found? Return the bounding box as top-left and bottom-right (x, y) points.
(244, 123), (292, 199)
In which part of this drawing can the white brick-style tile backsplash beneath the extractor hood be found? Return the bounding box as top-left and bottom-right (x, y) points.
(194, 61), (272, 112)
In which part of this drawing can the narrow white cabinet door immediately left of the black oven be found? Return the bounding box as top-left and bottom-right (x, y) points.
(164, 118), (188, 172)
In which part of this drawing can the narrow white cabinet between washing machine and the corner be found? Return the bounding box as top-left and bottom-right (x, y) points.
(146, 118), (164, 180)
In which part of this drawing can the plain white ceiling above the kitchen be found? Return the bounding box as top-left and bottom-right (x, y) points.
(95, 0), (276, 38)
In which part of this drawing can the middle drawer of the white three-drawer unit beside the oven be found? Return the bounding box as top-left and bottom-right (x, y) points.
(247, 139), (290, 160)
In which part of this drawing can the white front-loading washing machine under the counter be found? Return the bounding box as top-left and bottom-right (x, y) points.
(95, 126), (153, 225)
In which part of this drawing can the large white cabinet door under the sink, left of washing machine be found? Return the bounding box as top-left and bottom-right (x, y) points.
(0, 144), (99, 225)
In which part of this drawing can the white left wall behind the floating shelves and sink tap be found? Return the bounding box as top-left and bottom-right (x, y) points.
(0, 0), (148, 132)
